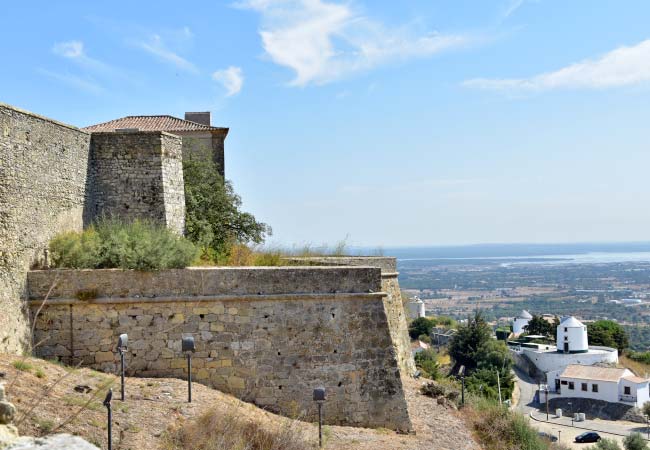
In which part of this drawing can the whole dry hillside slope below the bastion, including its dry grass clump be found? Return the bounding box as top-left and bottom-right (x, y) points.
(0, 355), (479, 450)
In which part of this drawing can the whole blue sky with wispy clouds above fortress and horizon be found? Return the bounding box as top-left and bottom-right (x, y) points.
(0, 0), (650, 247)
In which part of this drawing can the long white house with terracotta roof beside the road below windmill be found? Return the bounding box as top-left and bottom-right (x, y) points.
(548, 364), (650, 407)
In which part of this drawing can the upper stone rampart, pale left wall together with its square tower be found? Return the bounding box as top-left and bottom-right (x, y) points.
(0, 103), (185, 352)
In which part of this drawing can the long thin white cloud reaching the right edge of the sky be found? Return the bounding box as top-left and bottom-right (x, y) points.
(463, 39), (650, 93)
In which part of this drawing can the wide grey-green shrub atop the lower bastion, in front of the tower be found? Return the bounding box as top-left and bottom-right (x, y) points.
(50, 219), (197, 270)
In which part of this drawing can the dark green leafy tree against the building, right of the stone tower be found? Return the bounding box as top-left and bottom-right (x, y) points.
(183, 158), (271, 261)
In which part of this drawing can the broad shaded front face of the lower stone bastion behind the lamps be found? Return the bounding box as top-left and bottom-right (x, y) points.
(29, 267), (412, 431)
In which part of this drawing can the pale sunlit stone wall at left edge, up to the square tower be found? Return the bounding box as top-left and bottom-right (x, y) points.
(0, 103), (90, 352)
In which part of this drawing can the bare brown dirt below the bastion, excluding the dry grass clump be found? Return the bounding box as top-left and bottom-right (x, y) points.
(0, 355), (480, 450)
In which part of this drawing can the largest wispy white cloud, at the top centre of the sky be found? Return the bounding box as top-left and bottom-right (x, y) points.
(236, 0), (469, 86)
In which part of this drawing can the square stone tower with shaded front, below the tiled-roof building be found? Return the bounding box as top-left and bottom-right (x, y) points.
(89, 131), (185, 233)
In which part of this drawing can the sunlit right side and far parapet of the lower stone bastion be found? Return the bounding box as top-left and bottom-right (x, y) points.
(290, 256), (416, 375)
